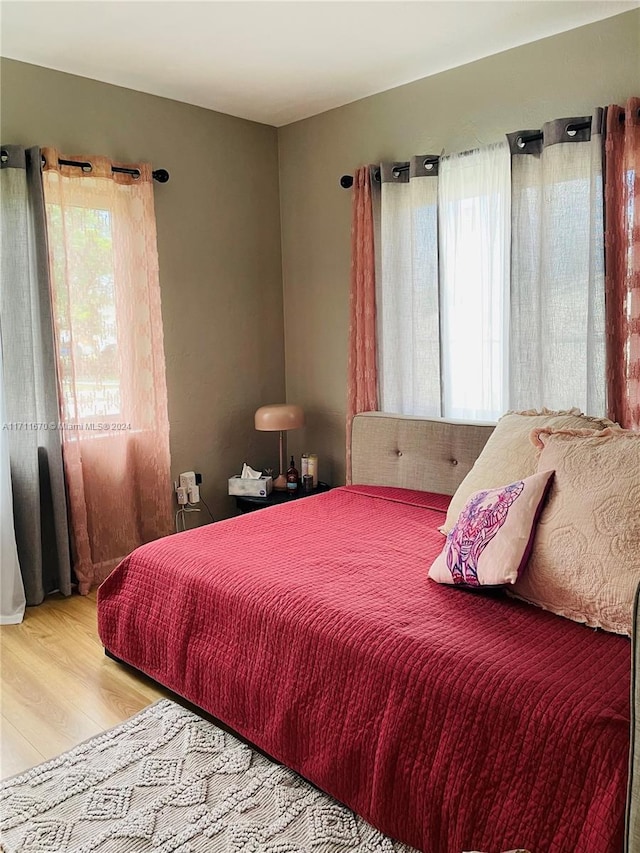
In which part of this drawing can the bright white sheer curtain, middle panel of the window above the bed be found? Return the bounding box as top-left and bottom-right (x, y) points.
(438, 142), (511, 421)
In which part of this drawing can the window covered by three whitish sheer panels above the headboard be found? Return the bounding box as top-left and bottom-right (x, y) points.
(378, 134), (605, 421)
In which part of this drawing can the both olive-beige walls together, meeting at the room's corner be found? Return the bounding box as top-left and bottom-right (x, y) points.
(1, 11), (640, 502)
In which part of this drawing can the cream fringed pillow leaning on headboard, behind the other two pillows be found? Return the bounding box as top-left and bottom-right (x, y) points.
(440, 409), (615, 533)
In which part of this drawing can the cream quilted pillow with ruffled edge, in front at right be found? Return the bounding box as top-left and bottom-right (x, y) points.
(511, 428), (640, 635)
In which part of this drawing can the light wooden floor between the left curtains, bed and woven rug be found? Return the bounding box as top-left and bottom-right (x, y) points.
(0, 592), (175, 778)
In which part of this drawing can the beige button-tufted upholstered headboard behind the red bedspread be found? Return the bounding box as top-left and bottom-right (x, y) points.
(351, 412), (493, 495)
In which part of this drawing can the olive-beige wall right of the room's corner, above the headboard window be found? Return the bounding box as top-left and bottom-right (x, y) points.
(278, 11), (640, 483)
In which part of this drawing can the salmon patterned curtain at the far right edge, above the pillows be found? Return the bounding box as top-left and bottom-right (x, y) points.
(605, 98), (640, 430)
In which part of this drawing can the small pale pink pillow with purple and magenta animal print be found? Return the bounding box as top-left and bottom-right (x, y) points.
(429, 471), (553, 586)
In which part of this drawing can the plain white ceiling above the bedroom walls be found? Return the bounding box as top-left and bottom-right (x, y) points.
(0, 0), (640, 127)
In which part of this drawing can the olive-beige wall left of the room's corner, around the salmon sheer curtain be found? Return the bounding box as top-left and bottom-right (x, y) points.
(1, 60), (284, 521)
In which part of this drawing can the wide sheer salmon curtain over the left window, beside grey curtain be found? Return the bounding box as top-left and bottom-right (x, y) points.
(43, 149), (172, 594)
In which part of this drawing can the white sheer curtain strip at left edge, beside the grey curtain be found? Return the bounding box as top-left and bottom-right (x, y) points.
(0, 329), (25, 625)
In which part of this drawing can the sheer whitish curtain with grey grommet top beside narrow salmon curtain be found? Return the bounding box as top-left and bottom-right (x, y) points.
(377, 155), (441, 417)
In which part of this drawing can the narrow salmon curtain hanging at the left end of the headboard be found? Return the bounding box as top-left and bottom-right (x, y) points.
(347, 166), (378, 483)
